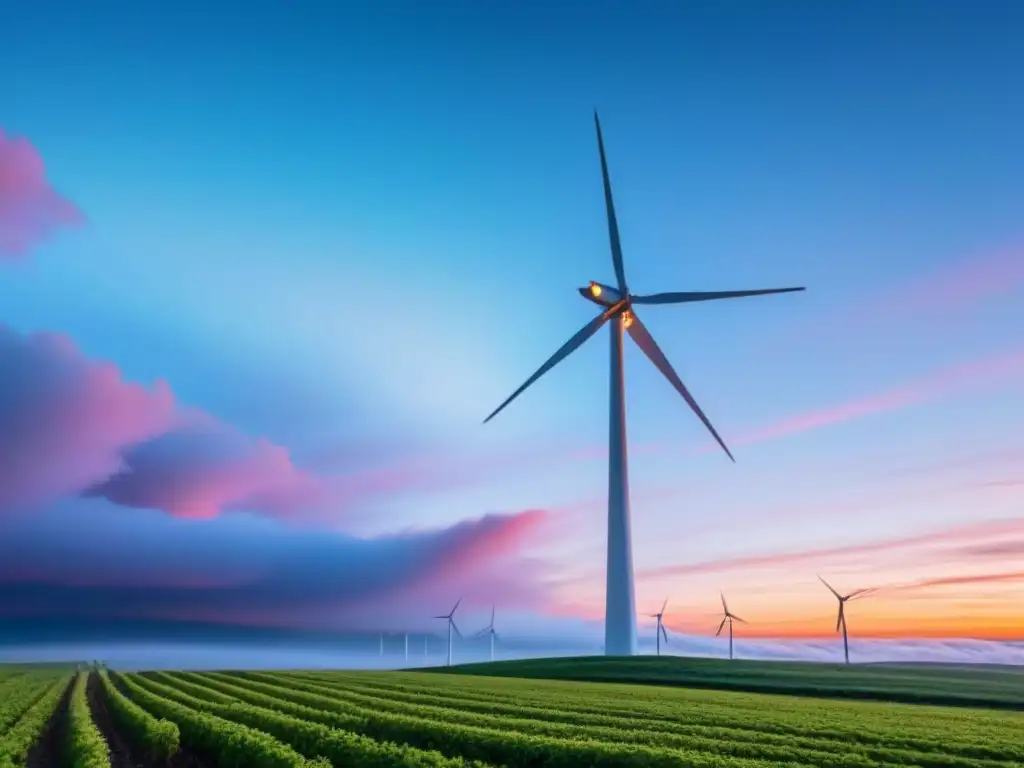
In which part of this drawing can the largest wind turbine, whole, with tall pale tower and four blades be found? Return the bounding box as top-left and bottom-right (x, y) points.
(484, 112), (804, 656)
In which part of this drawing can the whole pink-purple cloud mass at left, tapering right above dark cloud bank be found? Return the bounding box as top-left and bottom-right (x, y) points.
(0, 327), (462, 519)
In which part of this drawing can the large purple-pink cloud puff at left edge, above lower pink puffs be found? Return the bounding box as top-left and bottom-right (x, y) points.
(0, 326), (176, 511)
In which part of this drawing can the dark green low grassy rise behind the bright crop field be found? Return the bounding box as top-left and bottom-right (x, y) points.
(417, 656), (1024, 710)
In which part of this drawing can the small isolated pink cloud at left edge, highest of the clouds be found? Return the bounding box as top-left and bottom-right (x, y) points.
(0, 128), (84, 261)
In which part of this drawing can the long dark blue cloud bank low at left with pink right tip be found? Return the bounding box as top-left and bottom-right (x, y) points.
(0, 502), (546, 627)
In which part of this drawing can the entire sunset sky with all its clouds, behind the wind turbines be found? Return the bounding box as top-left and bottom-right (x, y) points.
(0, 0), (1024, 660)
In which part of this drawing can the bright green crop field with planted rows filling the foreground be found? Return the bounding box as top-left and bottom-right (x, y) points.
(0, 665), (1024, 768)
